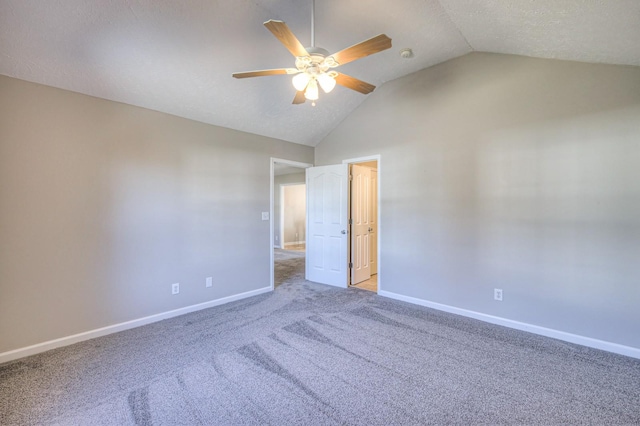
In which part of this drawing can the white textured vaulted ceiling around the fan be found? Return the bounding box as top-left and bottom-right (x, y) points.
(0, 0), (640, 146)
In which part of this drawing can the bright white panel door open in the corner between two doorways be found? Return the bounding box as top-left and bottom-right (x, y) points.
(306, 164), (349, 288)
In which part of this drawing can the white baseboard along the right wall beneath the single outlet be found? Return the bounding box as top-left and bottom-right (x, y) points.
(378, 290), (640, 359)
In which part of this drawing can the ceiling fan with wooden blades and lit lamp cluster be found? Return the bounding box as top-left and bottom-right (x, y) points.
(232, 0), (391, 106)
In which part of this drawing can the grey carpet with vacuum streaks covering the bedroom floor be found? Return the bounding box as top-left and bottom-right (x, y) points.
(0, 255), (640, 425)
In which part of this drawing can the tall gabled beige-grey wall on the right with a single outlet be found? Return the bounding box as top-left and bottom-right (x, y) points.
(315, 53), (640, 348)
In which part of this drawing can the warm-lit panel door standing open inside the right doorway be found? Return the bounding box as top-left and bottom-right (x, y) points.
(351, 164), (372, 284)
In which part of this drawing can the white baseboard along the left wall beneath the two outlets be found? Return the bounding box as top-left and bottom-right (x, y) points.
(0, 287), (271, 364)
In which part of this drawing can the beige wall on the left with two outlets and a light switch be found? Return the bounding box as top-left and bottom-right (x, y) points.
(0, 76), (313, 353)
